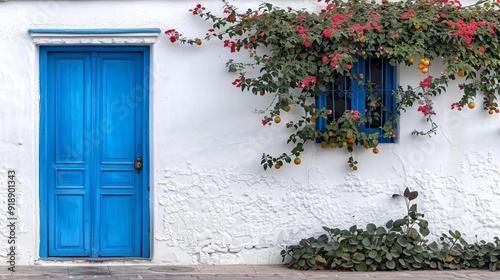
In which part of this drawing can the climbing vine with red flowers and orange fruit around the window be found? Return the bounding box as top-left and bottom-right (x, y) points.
(165, 0), (500, 170)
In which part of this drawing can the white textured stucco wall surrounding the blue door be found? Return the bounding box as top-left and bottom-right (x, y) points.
(0, 0), (500, 264)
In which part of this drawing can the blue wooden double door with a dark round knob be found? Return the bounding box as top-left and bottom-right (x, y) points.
(40, 47), (149, 258)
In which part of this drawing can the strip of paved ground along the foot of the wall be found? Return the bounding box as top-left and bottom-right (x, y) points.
(0, 264), (500, 280)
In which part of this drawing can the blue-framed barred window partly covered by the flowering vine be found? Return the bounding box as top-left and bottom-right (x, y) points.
(316, 57), (397, 143)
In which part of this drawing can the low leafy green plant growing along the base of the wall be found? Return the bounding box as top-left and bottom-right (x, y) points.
(281, 188), (500, 271)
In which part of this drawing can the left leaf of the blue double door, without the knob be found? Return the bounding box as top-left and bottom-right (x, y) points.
(47, 53), (91, 256)
